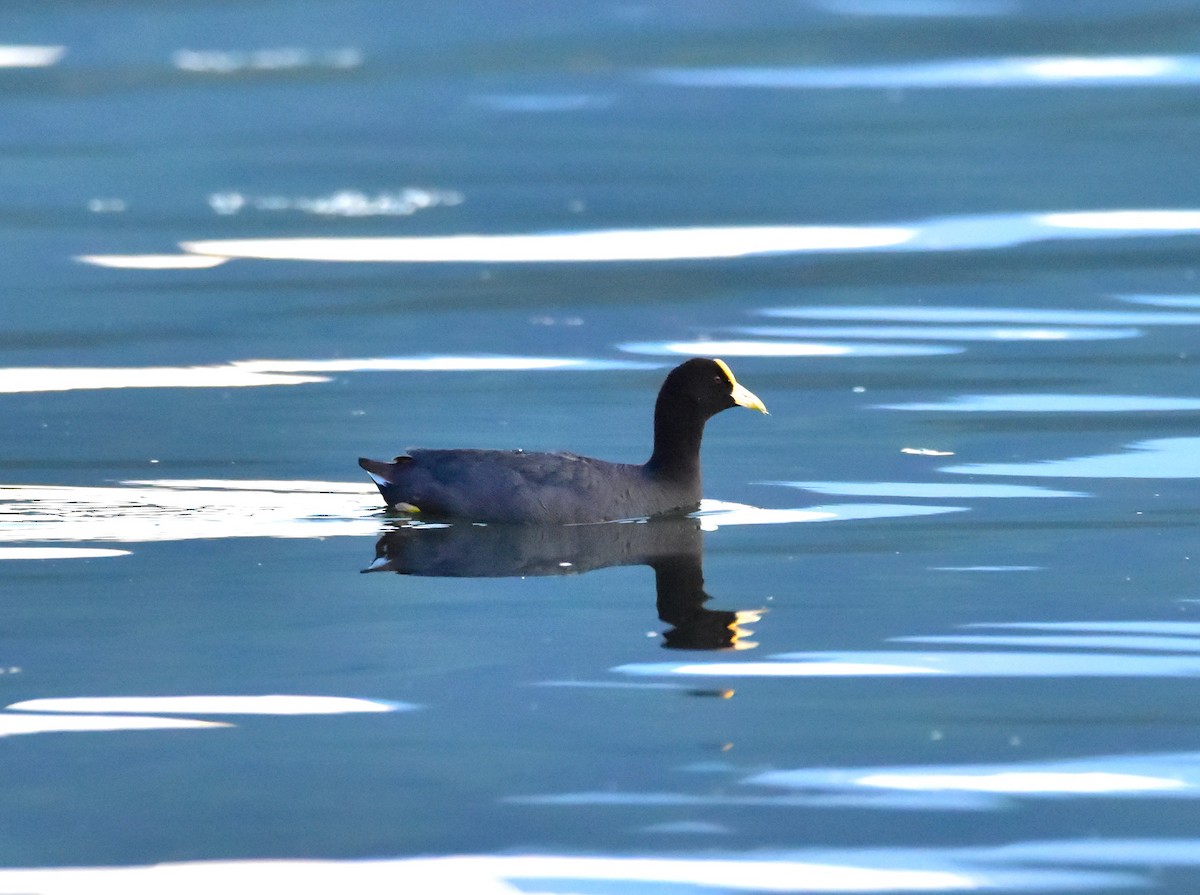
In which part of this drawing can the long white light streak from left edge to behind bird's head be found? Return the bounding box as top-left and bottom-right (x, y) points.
(0, 355), (660, 395)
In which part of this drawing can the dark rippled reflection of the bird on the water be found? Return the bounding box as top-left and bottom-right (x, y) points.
(364, 516), (763, 649)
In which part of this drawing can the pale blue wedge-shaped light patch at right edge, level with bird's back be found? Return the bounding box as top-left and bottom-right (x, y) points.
(941, 437), (1200, 479)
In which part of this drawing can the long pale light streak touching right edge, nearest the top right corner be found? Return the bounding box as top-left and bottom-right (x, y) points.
(647, 55), (1200, 90)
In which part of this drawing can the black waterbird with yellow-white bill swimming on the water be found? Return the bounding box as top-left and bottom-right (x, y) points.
(359, 358), (767, 523)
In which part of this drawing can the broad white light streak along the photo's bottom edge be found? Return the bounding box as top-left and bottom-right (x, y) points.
(0, 848), (1104, 895)
